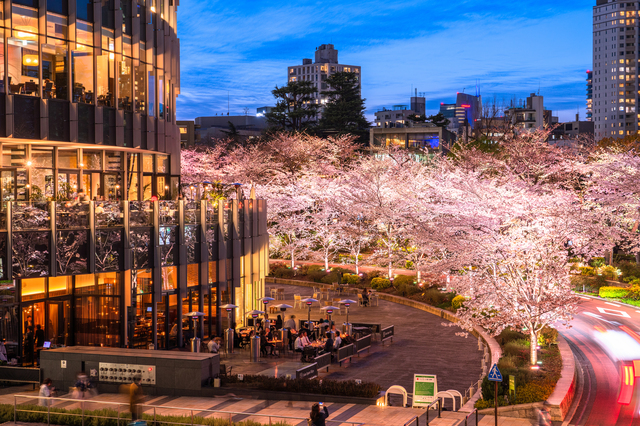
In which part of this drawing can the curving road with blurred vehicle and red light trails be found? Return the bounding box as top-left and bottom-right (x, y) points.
(557, 297), (640, 426)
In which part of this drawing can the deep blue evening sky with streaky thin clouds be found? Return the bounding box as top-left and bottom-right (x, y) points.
(177, 0), (595, 121)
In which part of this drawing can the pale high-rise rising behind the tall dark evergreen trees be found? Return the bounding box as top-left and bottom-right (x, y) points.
(288, 44), (362, 104)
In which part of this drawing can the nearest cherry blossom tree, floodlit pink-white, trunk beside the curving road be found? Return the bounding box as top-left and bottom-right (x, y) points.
(423, 165), (607, 365)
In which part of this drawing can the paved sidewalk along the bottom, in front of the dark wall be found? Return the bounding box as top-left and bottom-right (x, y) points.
(0, 392), (534, 426)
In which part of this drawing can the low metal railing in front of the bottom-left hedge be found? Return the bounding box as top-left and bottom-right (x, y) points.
(13, 395), (364, 426)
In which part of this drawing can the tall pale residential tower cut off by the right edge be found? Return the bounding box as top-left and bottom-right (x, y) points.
(592, 0), (640, 140)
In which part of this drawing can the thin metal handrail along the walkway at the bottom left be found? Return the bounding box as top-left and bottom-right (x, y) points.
(13, 395), (365, 426)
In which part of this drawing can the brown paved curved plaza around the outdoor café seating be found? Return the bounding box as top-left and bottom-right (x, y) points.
(228, 285), (482, 395)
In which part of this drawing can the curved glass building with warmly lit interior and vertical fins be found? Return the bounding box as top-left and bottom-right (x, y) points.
(0, 0), (268, 364)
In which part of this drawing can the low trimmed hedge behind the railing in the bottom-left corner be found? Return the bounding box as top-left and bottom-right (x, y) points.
(0, 401), (288, 426)
